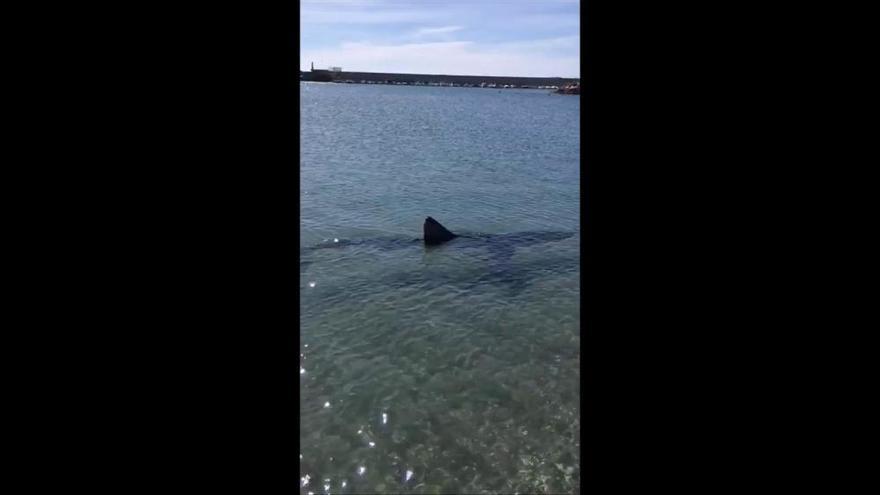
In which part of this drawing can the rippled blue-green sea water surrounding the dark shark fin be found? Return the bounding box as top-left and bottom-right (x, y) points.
(299, 83), (580, 494)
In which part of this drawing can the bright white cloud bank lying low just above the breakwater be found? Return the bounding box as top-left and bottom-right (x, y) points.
(300, 36), (580, 77)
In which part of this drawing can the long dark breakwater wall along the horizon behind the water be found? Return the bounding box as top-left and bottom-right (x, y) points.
(300, 70), (578, 88)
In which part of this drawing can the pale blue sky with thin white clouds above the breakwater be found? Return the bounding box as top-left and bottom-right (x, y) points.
(300, 0), (580, 78)
